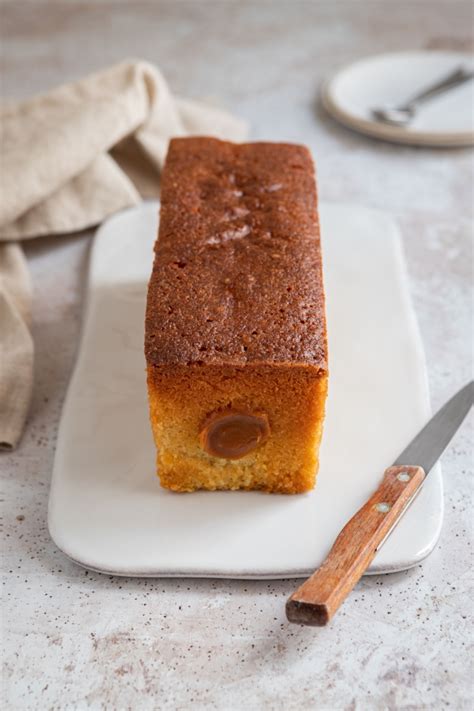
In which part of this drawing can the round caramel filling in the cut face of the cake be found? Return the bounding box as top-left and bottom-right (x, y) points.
(199, 411), (270, 459)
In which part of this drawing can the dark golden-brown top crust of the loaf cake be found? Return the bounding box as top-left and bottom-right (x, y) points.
(145, 138), (327, 372)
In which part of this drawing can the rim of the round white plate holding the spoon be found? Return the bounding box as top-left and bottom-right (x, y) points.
(321, 50), (474, 148)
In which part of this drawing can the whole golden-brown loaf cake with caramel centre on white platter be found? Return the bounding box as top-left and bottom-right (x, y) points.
(145, 137), (327, 493)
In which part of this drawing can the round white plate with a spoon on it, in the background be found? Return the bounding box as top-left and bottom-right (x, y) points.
(322, 51), (474, 147)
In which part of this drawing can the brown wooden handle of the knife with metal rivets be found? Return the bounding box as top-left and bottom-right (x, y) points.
(286, 466), (426, 627)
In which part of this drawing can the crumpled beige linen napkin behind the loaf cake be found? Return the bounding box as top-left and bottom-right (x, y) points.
(0, 61), (246, 448)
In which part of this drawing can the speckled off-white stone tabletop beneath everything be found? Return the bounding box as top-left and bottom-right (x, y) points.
(0, 0), (473, 711)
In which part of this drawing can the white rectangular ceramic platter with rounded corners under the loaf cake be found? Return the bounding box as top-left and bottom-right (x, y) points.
(49, 203), (442, 578)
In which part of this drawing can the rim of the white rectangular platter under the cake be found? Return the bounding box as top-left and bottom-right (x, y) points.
(48, 201), (443, 580)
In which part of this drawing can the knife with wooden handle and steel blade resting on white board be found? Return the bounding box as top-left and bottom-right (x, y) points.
(286, 380), (474, 627)
